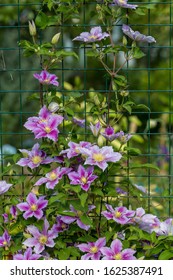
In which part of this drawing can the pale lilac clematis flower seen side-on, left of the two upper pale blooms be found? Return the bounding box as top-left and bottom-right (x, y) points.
(73, 26), (110, 43)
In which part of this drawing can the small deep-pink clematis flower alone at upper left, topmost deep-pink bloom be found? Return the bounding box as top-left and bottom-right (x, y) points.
(33, 70), (59, 87)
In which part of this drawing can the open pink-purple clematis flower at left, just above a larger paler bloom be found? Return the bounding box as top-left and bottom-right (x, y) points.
(17, 193), (48, 220)
